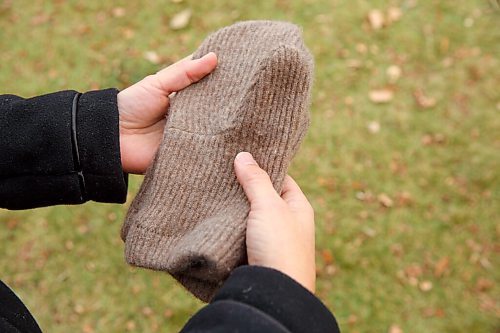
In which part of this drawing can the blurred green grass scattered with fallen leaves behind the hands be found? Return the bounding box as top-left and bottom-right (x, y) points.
(0, 0), (500, 333)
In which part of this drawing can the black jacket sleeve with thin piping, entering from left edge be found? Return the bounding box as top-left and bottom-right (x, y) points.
(0, 89), (128, 209)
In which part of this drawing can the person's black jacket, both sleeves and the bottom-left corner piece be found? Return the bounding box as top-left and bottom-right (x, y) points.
(0, 89), (339, 333)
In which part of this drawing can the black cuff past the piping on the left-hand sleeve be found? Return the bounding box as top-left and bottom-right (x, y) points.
(76, 89), (128, 203)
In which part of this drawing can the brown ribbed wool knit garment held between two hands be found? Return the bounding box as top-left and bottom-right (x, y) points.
(122, 21), (313, 301)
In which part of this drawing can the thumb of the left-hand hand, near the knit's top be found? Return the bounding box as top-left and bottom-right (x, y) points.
(156, 52), (217, 95)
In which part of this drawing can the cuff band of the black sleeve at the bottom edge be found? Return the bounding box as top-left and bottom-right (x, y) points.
(212, 266), (340, 332)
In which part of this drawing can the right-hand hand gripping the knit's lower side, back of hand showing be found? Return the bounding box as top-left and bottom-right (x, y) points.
(234, 152), (316, 292)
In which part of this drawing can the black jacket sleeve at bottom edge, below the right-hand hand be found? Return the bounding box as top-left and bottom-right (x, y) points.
(182, 266), (340, 333)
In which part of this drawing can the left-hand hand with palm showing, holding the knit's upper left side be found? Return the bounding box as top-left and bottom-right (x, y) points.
(118, 52), (217, 173)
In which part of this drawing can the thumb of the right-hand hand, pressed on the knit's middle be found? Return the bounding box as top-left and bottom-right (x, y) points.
(234, 152), (279, 204)
